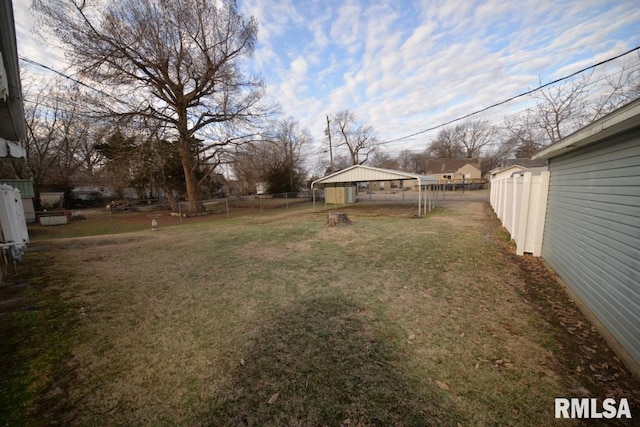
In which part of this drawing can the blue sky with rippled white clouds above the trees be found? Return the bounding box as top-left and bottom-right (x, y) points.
(13, 0), (640, 166)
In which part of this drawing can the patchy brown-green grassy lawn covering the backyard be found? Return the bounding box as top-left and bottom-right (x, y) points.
(0, 202), (636, 426)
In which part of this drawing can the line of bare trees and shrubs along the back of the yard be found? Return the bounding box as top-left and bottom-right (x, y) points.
(0, 0), (640, 212)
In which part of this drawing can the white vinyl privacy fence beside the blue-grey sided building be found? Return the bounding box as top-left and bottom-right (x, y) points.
(491, 171), (549, 256)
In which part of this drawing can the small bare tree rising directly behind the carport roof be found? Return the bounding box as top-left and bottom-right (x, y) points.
(332, 110), (378, 165)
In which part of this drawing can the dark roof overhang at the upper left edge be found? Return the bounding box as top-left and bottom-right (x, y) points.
(0, 0), (27, 145)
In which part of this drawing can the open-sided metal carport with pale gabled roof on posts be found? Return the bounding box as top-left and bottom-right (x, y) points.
(311, 165), (439, 217)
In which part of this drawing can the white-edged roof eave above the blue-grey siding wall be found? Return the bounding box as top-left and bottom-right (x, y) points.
(532, 98), (640, 159)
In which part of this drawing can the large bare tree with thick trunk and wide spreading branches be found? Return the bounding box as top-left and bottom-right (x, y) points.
(33, 0), (264, 211)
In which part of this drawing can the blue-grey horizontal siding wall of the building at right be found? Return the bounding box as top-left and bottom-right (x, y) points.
(542, 130), (640, 363)
